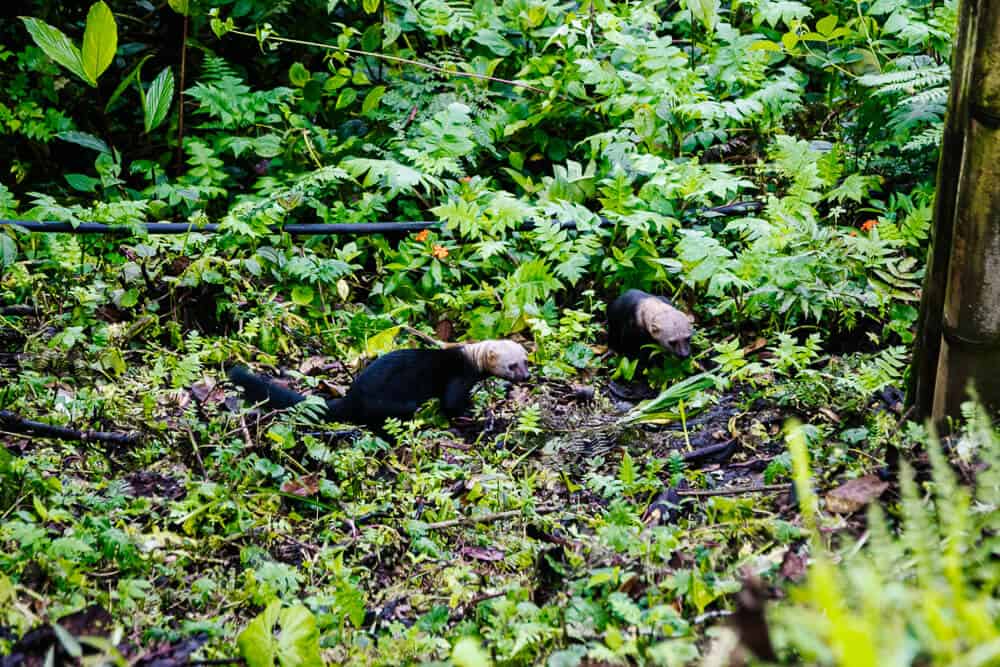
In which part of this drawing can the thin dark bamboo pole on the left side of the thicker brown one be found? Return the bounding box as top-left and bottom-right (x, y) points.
(907, 0), (983, 420)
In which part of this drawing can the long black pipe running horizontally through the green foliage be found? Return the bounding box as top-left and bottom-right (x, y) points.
(0, 201), (764, 236)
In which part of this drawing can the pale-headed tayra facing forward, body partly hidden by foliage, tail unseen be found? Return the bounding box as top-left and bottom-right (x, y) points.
(608, 289), (691, 358)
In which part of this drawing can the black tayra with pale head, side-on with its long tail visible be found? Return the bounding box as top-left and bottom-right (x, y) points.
(229, 340), (529, 429)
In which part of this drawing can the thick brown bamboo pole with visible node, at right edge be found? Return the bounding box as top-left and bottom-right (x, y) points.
(931, 1), (1000, 421)
